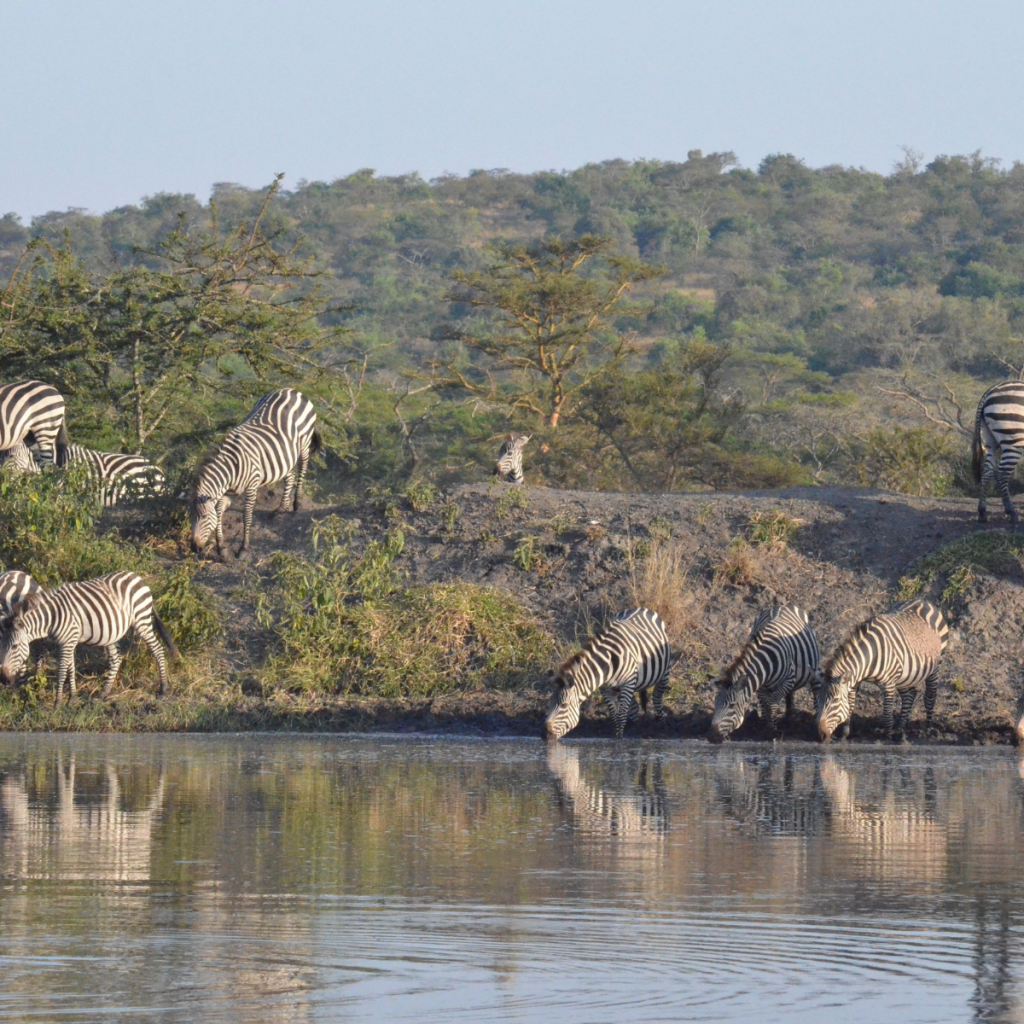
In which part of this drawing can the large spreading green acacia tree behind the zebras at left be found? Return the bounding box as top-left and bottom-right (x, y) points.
(0, 175), (352, 451)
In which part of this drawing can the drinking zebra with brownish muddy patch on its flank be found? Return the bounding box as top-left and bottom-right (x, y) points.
(816, 601), (949, 742)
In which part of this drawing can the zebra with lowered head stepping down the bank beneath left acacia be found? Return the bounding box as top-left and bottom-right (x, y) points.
(188, 388), (321, 558)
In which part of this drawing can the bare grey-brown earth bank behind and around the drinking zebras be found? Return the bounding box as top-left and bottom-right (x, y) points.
(184, 484), (1024, 743)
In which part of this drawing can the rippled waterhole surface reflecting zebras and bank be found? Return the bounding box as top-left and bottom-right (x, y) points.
(0, 735), (1024, 1024)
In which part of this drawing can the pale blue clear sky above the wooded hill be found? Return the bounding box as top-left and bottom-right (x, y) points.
(0, 0), (1024, 222)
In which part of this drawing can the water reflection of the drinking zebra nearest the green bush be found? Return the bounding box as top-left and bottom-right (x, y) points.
(548, 745), (669, 843)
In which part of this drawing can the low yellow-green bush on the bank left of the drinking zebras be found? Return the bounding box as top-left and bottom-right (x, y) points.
(250, 517), (553, 697)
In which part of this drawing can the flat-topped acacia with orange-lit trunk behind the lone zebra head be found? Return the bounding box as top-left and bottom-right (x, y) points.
(434, 234), (662, 429)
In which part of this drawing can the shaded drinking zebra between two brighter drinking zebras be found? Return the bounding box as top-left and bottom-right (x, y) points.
(708, 604), (821, 743)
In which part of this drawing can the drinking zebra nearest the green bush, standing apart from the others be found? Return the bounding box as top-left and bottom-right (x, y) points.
(544, 608), (672, 739)
